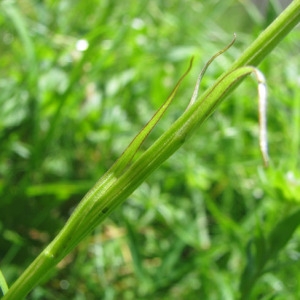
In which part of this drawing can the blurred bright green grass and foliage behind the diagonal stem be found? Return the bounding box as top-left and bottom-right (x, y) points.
(0, 0), (300, 299)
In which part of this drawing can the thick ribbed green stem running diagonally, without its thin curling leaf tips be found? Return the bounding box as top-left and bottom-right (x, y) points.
(2, 0), (300, 300)
